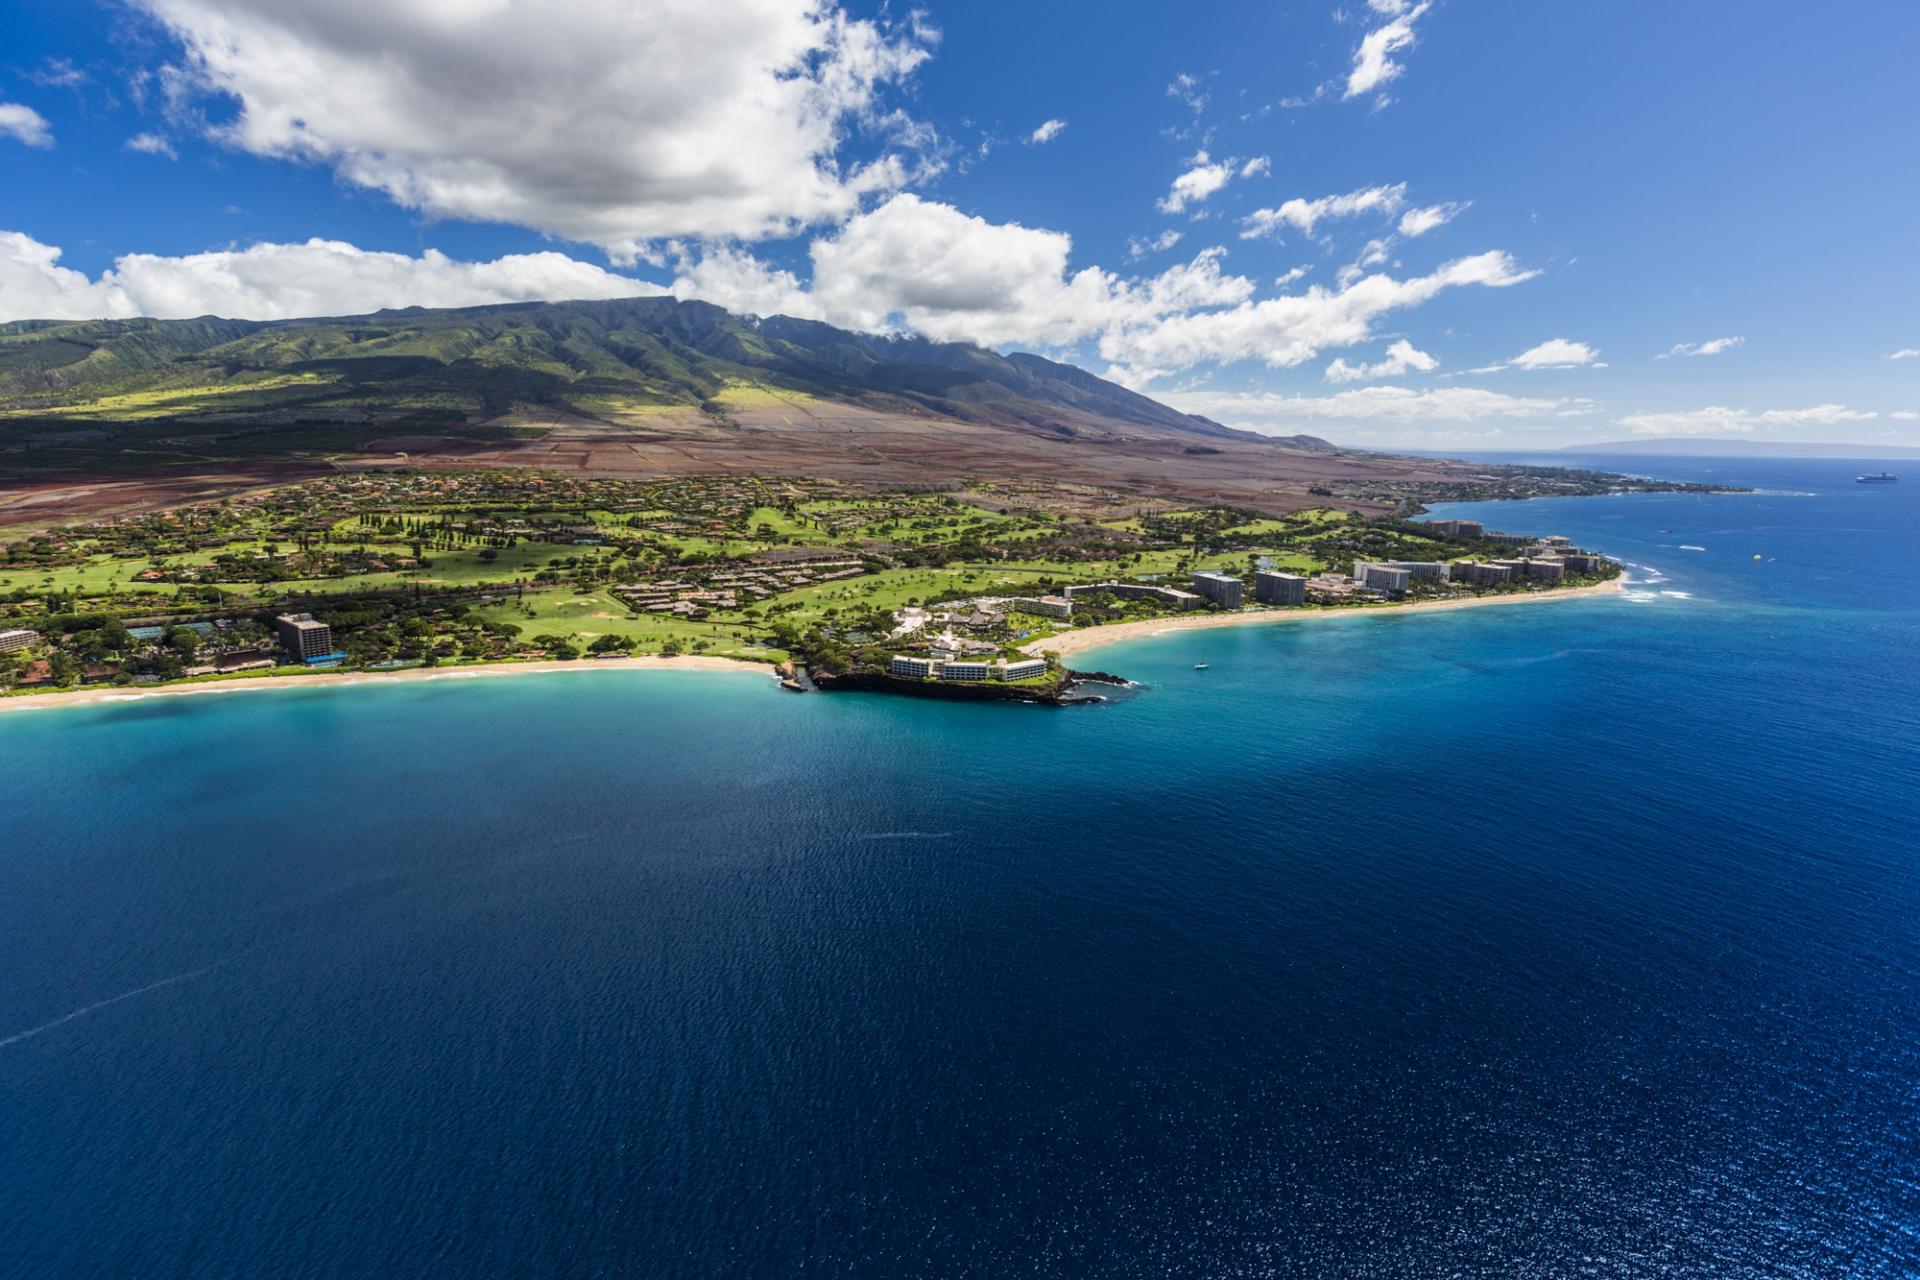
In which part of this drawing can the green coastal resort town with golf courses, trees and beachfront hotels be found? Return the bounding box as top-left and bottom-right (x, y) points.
(0, 470), (1619, 697)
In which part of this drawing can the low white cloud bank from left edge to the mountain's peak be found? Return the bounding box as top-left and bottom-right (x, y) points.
(0, 232), (662, 320)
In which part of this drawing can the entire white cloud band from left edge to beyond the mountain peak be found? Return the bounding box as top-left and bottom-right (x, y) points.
(0, 194), (1534, 395)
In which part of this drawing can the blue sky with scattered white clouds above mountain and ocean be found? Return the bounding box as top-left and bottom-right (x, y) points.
(0, 0), (1920, 451)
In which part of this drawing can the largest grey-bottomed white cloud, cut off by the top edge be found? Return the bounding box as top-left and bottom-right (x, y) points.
(134, 0), (939, 261)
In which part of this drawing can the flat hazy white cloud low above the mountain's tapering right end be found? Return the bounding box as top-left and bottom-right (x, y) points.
(1160, 386), (1594, 436)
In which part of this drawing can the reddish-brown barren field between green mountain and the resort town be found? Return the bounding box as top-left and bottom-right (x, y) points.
(0, 397), (1473, 526)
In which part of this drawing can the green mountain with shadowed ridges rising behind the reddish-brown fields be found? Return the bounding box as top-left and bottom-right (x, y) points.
(0, 297), (1246, 439)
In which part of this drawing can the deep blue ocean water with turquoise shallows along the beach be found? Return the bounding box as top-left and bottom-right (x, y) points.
(0, 459), (1920, 1278)
